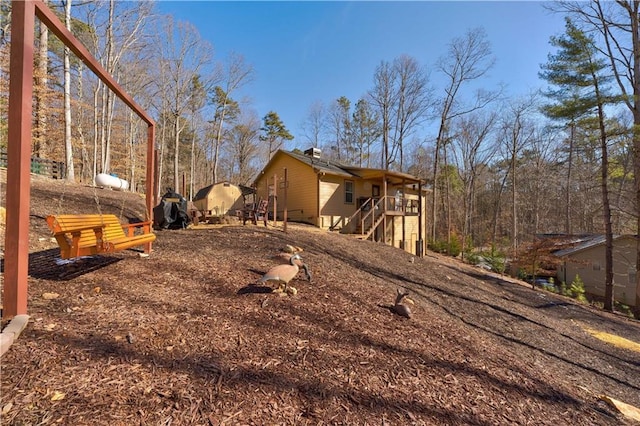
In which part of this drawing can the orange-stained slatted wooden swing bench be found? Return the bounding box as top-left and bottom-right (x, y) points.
(47, 214), (156, 259)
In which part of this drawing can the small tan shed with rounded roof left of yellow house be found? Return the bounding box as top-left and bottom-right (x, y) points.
(193, 181), (244, 217)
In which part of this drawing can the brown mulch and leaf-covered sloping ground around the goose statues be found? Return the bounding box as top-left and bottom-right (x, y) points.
(0, 171), (640, 425)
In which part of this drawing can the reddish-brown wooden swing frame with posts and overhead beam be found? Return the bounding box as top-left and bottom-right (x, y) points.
(2, 0), (156, 320)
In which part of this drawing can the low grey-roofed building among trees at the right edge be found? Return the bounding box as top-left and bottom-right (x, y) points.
(554, 235), (637, 306)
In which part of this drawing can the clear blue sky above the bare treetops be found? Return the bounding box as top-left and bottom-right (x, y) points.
(158, 1), (564, 149)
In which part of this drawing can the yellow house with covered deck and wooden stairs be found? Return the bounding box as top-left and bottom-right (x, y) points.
(254, 149), (426, 256)
